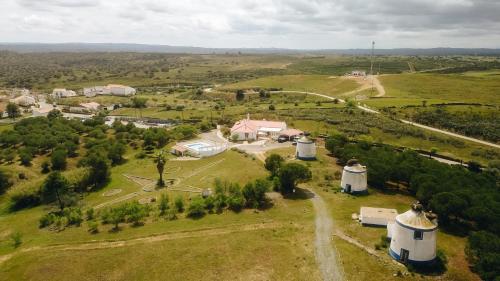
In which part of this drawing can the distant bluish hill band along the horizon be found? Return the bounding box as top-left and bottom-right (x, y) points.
(0, 43), (500, 56)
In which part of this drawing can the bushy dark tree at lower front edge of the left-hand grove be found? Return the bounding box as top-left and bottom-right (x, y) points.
(42, 171), (75, 212)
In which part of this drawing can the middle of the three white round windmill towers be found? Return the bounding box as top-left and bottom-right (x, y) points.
(340, 159), (368, 193)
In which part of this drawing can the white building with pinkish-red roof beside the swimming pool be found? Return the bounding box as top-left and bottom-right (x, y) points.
(231, 115), (287, 140)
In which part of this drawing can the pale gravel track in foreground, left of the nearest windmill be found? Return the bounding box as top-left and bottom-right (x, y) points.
(309, 190), (344, 281)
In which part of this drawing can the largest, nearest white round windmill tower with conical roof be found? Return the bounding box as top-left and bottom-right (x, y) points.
(389, 202), (437, 266)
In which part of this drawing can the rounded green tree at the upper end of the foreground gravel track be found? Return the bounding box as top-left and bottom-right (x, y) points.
(278, 163), (312, 194)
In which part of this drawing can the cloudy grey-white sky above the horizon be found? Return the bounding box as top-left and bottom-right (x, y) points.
(0, 0), (500, 49)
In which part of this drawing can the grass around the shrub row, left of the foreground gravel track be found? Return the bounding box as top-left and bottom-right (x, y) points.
(0, 148), (320, 280)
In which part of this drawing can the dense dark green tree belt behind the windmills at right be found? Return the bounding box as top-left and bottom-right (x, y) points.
(326, 135), (500, 280)
